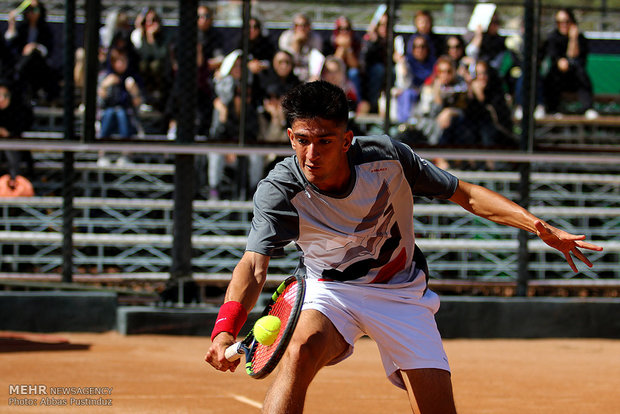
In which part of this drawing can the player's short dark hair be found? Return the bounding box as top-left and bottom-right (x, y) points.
(282, 80), (349, 126)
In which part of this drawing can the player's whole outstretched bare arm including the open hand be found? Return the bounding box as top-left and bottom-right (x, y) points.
(450, 181), (603, 272)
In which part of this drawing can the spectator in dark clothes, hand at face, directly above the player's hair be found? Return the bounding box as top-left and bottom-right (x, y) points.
(323, 16), (362, 102)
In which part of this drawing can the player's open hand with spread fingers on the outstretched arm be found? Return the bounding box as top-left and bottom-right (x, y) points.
(534, 220), (603, 273)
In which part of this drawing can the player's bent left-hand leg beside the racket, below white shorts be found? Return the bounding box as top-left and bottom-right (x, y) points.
(263, 310), (349, 414)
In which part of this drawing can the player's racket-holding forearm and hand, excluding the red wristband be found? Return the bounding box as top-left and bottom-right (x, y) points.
(205, 251), (269, 371)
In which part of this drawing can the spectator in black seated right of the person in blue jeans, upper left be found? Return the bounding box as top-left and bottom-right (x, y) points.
(132, 9), (171, 111)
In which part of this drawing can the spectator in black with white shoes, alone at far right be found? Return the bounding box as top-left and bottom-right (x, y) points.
(543, 8), (598, 119)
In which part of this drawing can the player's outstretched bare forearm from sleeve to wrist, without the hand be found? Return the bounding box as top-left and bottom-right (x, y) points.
(450, 181), (540, 233)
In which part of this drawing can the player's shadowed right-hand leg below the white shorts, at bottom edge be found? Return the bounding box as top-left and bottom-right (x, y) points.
(401, 368), (456, 414)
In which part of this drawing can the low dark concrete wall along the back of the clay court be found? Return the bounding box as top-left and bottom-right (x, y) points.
(0, 292), (620, 338)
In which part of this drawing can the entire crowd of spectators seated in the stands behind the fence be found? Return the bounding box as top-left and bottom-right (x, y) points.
(0, 0), (598, 198)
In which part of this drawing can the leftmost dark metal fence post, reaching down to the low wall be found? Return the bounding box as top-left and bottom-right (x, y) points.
(62, 0), (75, 283)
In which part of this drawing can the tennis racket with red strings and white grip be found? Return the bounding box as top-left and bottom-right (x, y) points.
(225, 276), (306, 379)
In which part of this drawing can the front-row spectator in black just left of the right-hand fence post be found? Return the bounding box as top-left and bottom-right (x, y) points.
(465, 60), (516, 152)
